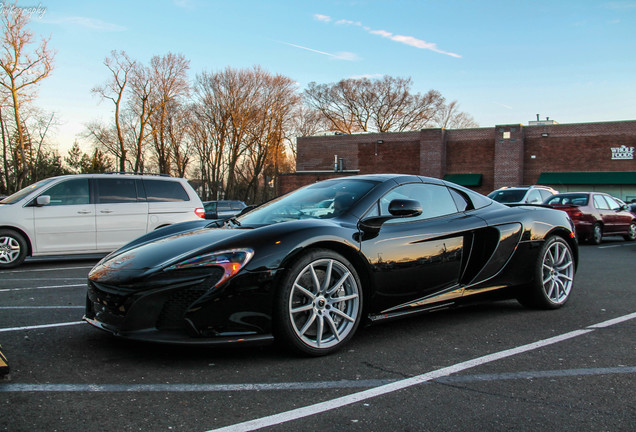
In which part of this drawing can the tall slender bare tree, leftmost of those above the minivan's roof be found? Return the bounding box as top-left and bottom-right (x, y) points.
(91, 50), (135, 172)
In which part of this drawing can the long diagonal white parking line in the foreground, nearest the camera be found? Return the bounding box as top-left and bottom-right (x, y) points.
(208, 312), (636, 432)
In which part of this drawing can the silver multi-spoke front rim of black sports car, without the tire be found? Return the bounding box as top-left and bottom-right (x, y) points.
(288, 258), (360, 349)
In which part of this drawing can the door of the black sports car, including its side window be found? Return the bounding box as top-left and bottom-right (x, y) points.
(361, 183), (486, 312)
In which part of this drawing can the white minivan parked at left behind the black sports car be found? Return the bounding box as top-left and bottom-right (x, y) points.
(0, 174), (205, 268)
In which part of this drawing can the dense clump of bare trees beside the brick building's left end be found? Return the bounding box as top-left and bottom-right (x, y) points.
(194, 67), (299, 202)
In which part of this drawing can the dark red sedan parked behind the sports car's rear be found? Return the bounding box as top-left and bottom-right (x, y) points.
(545, 192), (636, 244)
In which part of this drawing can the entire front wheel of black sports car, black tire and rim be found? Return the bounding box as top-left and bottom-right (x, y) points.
(274, 249), (362, 356)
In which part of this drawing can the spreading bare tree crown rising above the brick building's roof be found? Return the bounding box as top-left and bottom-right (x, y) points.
(305, 76), (444, 133)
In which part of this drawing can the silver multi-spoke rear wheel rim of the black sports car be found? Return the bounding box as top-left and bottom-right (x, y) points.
(543, 241), (574, 304)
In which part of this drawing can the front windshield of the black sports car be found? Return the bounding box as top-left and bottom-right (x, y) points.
(238, 179), (377, 225)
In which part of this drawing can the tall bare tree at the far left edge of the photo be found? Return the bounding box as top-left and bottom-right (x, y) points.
(0, 5), (54, 187)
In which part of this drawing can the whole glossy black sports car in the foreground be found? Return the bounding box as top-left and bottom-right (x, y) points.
(84, 174), (578, 355)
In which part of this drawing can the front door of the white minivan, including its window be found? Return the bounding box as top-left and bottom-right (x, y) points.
(33, 178), (95, 254)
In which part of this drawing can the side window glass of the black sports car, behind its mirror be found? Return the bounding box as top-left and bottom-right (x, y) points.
(379, 183), (458, 223)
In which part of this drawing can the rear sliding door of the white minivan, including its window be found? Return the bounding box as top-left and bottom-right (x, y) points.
(94, 176), (148, 251)
